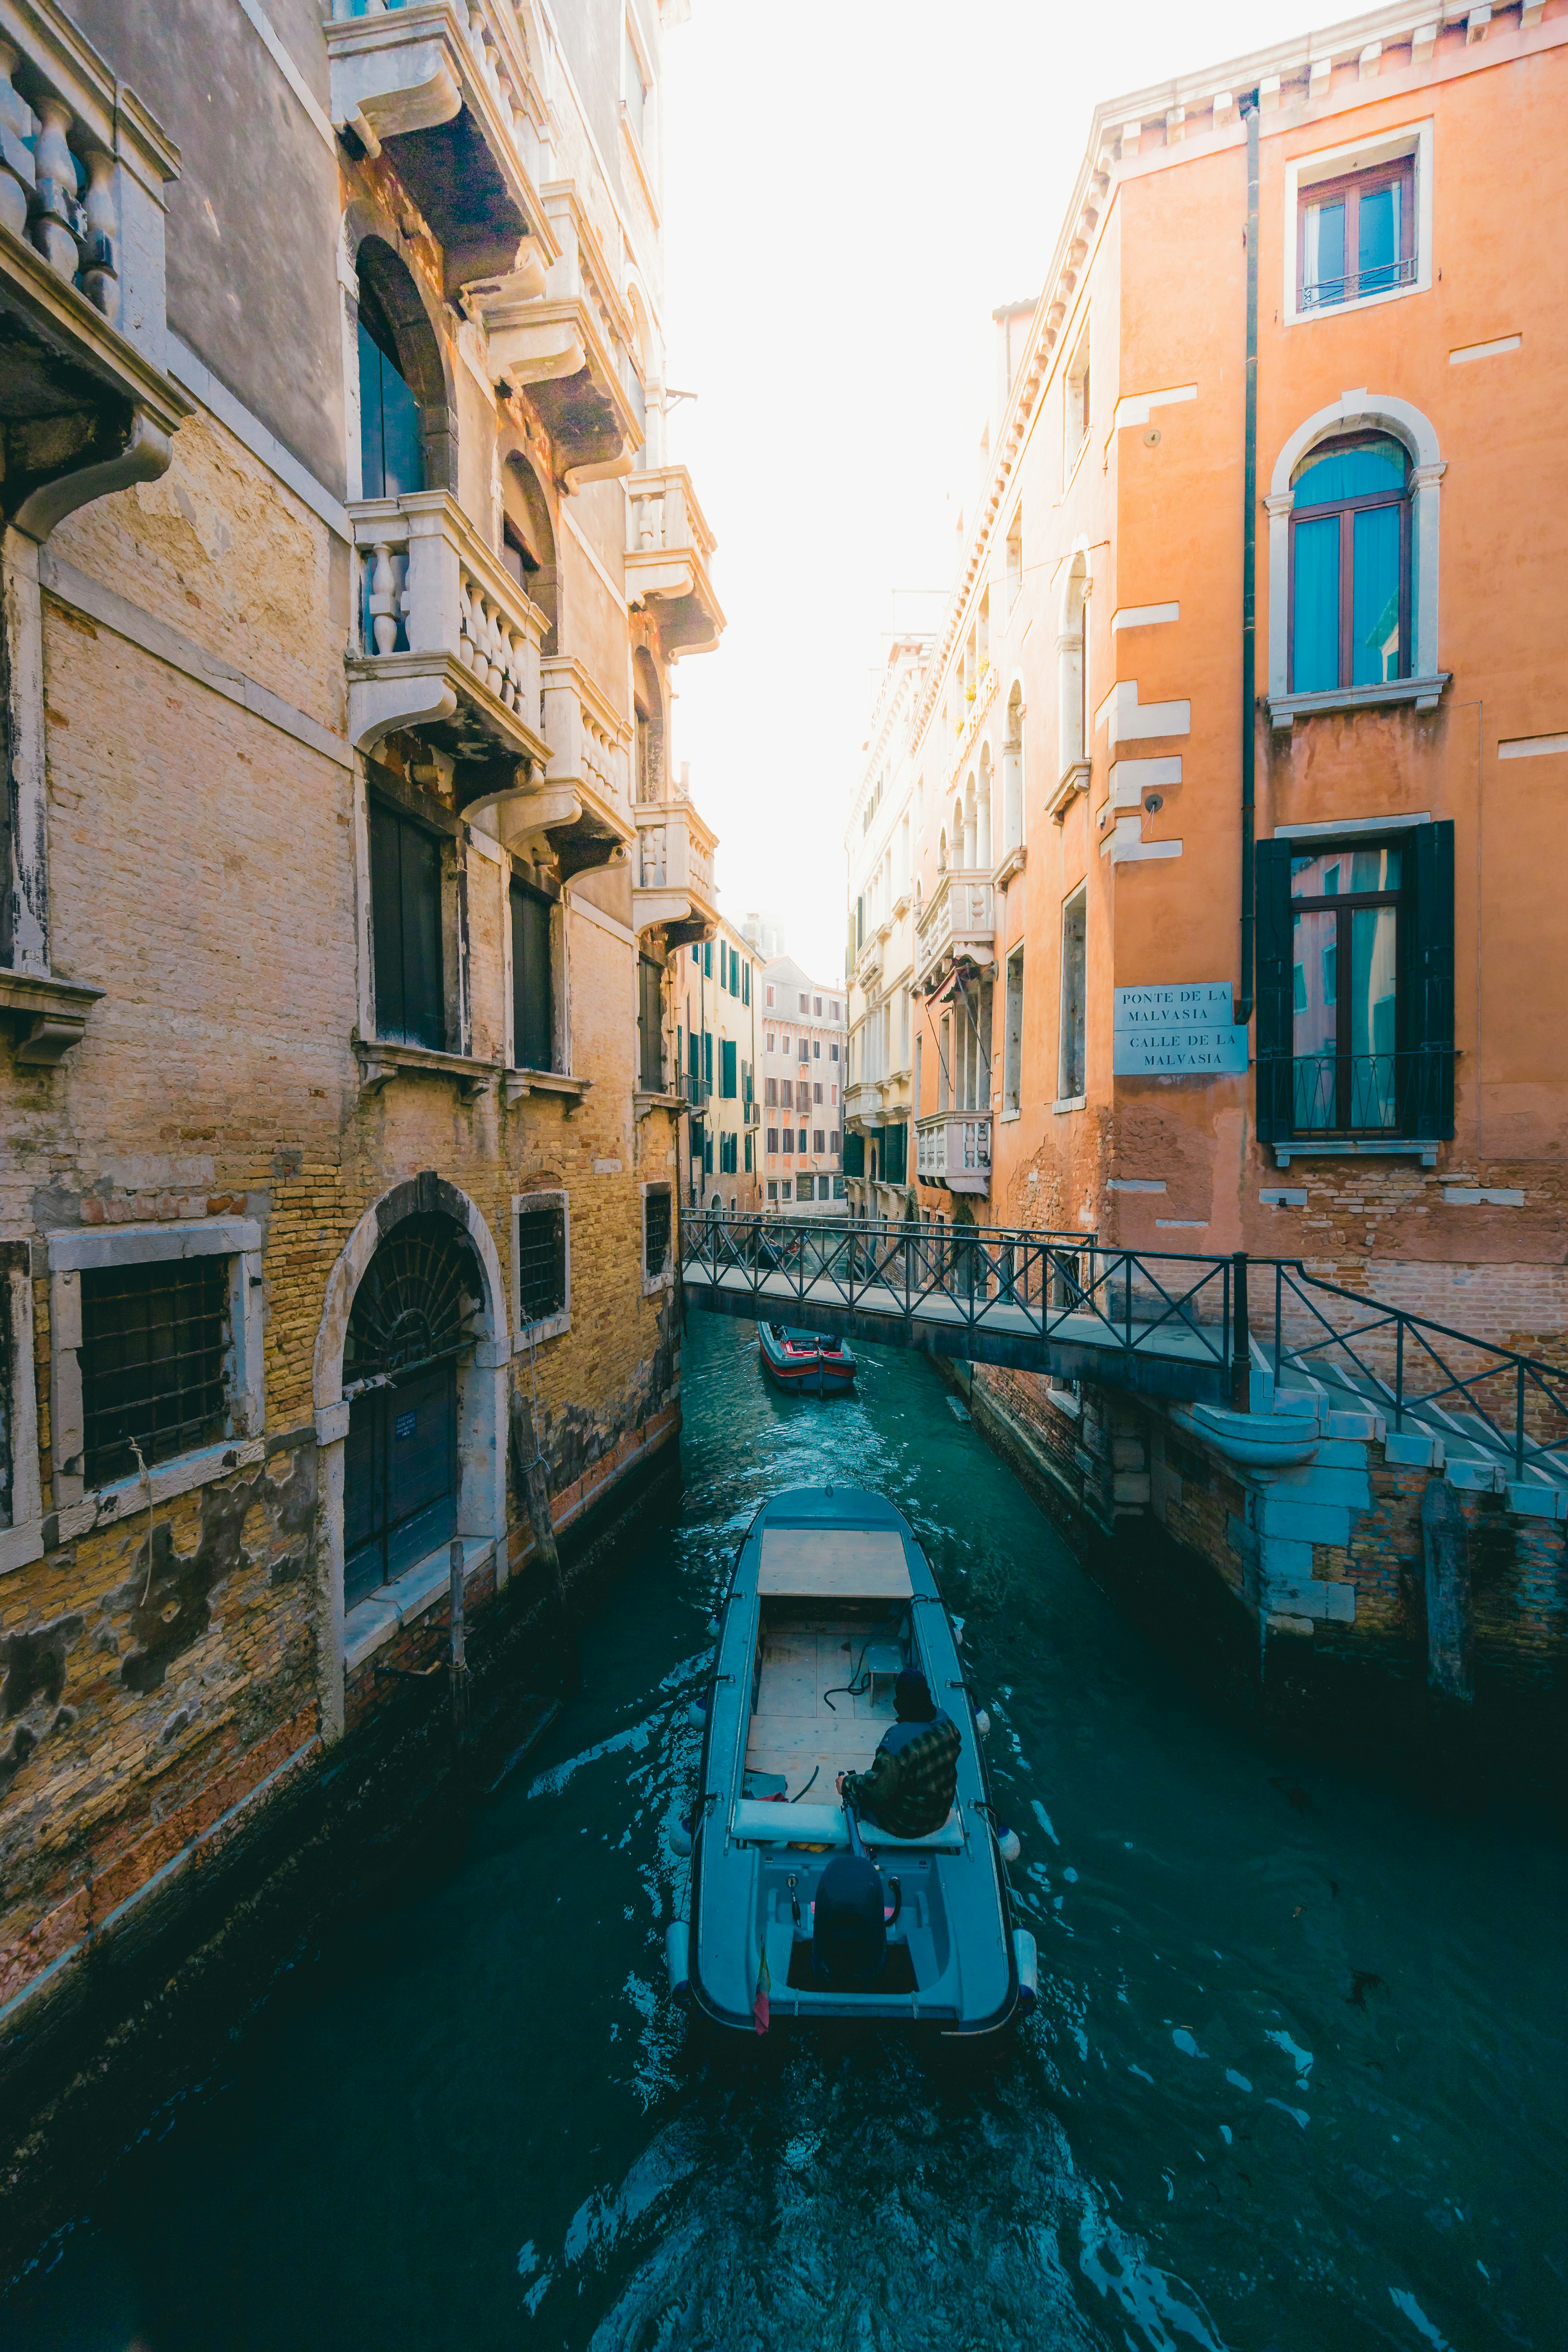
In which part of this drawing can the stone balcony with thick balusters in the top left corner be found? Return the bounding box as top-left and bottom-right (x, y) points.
(0, 0), (193, 541)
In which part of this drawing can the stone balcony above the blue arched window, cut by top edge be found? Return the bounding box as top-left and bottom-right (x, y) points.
(327, 0), (559, 301)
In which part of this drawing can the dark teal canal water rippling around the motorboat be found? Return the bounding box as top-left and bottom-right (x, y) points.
(0, 1315), (1568, 2352)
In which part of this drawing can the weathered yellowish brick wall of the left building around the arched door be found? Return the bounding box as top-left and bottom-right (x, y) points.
(0, 395), (679, 2032)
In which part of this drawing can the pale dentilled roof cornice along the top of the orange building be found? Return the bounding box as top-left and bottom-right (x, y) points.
(915, 0), (1544, 743)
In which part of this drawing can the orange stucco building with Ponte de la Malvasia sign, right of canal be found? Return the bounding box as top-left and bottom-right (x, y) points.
(849, 0), (1568, 1348)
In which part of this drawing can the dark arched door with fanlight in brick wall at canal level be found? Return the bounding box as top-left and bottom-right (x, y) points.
(343, 1211), (484, 1609)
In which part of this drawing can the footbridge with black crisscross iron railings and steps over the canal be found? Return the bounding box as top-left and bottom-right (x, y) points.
(679, 1211), (1568, 1484)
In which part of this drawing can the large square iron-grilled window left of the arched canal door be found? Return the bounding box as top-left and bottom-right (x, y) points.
(78, 1258), (230, 1486)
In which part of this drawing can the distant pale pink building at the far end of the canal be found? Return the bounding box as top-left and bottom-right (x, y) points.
(760, 955), (846, 1216)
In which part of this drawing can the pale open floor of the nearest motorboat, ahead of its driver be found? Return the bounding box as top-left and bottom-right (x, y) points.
(745, 1616), (903, 1802)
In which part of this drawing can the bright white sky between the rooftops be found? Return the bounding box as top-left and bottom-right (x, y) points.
(663, 0), (1333, 978)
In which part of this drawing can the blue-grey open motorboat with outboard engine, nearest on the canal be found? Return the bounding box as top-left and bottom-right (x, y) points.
(665, 1486), (1037, 2034)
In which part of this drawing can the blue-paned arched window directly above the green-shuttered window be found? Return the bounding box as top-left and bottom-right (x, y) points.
(1291, 433), (1410, 694)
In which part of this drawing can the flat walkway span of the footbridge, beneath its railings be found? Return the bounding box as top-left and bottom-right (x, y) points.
(684, 1258), (1225, 1399)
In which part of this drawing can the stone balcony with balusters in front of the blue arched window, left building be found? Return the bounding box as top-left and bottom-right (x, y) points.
(348, 489), (550, 762)
